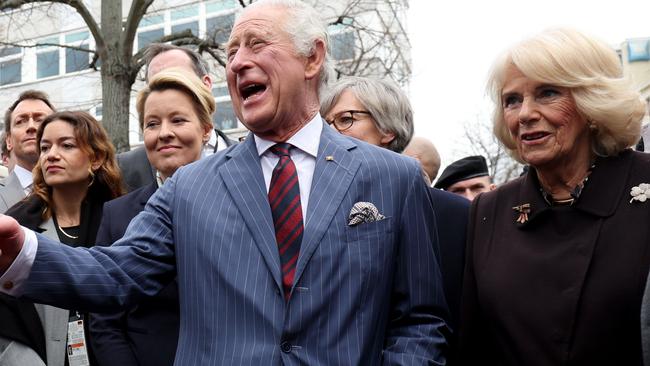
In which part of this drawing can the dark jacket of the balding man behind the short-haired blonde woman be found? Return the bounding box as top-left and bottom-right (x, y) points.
(117, 128), (237, 192)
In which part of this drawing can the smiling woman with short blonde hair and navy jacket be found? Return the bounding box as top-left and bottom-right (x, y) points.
(90, 68), (215, 366)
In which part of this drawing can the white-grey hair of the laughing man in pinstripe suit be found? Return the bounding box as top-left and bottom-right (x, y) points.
(239, 0), (334, 94)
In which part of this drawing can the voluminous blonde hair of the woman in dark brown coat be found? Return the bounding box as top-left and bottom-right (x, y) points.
(487, 28), (645, 162)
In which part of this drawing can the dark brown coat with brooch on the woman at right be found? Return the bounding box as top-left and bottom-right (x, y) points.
(460, 150), (650, 366)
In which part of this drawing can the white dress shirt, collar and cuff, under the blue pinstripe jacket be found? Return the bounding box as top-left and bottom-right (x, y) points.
(0, 113), (323, 296)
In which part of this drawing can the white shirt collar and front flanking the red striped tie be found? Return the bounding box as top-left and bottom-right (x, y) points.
(253, 113), (323, 222)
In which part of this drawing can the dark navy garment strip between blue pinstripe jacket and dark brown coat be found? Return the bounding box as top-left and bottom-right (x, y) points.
(431, 188), (470, 338)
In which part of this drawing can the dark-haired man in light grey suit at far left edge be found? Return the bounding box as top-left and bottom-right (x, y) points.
(0, 90), (54, 213)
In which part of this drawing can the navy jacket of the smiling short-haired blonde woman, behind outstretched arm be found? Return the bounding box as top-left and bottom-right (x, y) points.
(90, 183), (179, 366)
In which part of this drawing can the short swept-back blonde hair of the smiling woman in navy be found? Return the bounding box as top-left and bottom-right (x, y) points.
(136, 67), (216, 131)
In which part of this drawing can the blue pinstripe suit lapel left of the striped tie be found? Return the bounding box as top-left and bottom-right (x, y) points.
(219, 134), (282, 289)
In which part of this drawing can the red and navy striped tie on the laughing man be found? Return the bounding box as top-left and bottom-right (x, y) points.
(269, 143), (303, 300)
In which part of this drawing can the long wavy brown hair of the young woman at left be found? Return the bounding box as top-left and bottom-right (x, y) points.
(32, 111), (125, 220)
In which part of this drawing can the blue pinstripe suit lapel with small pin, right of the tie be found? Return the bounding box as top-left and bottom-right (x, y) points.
(294, 125), (361, 284)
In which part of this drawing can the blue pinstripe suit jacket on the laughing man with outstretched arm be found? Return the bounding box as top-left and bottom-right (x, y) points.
(23, 126), (446, 365)
